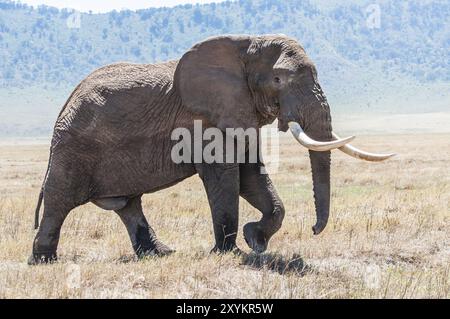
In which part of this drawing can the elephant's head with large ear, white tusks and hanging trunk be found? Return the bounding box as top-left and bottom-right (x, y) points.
(174, 35), (393, 234)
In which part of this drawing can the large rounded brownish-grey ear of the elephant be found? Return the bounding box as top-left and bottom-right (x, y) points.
(174, 36), (258, 130)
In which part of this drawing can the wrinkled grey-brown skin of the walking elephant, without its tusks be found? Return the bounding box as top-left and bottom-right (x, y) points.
(29, 35), (332, 264)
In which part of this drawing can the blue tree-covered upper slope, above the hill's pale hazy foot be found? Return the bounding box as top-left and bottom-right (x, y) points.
(0, 0), (450, 87)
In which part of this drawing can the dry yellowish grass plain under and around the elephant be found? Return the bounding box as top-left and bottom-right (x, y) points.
(0, 134), (450, 298)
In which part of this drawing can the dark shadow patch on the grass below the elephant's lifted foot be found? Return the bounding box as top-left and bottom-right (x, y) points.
(241, 253), (313, 277)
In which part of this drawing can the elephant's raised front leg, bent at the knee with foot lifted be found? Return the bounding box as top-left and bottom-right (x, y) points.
(240, 163), (285, 253)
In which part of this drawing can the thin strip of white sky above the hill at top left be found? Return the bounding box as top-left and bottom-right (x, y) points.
(18, 0), (223, 12)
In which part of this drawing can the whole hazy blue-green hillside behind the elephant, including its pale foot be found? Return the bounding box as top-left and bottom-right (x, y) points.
(0, 0), (450, 135)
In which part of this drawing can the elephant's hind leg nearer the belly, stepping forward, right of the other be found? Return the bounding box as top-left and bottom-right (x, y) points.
(115, 195), (173, 257)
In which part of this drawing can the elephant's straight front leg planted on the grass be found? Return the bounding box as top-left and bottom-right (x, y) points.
(197, 163), (239, 253)
